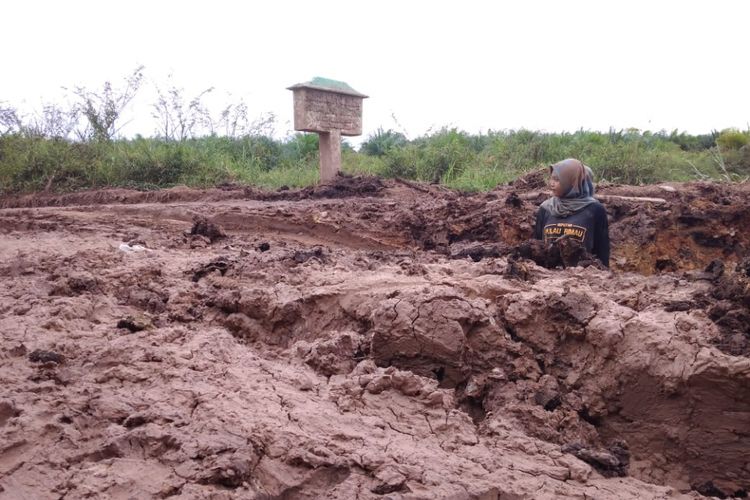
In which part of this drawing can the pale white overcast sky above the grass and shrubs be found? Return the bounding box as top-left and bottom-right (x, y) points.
(0, 0), (750, 142)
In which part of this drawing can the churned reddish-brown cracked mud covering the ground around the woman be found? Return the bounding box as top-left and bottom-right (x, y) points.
(0, 175), (750, 499)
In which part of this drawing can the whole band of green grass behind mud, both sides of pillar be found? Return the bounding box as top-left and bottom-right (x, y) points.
(0, 129), (750, 194)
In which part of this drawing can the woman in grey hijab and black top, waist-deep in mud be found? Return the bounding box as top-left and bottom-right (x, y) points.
(534, 158), (609, 267)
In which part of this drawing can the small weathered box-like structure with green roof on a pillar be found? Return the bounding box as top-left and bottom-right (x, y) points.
(289, 77), (367, 182)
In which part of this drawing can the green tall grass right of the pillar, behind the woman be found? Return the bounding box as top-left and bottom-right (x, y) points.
(362, 129), (750, 190)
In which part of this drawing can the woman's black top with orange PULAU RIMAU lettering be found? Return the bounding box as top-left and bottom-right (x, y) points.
(534, 202), (609, 267)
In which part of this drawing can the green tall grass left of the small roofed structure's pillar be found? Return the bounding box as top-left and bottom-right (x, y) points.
(0, 134), (318, 193)
